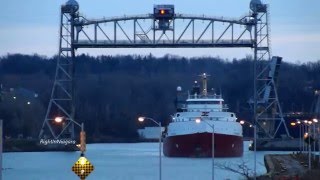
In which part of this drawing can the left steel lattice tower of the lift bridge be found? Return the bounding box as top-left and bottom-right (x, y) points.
(39, 3), (79, 139)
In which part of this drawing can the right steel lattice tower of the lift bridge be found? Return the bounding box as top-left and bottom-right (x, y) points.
(250, 0), (290, 139)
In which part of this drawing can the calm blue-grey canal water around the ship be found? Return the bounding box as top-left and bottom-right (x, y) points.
(3, 142), (286, 180)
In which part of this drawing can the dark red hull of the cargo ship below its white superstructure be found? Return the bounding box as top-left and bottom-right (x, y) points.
(163, 133), (243, 157)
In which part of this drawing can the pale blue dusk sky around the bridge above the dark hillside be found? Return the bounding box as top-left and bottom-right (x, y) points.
(0, 0), (320, 62)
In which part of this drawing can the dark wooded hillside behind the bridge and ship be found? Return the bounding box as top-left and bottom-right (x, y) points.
(0, 54), (320, 142)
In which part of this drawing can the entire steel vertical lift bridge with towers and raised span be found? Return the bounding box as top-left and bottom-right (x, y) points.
(39, 0), (289, 141)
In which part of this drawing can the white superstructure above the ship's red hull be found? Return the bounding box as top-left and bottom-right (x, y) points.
(167, 73), (242, 136)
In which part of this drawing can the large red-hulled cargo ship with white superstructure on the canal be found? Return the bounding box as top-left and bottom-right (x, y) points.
(163, 73), (243, 157)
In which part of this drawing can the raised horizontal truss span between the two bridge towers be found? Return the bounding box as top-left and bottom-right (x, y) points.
(73, 14), (254, 48)
